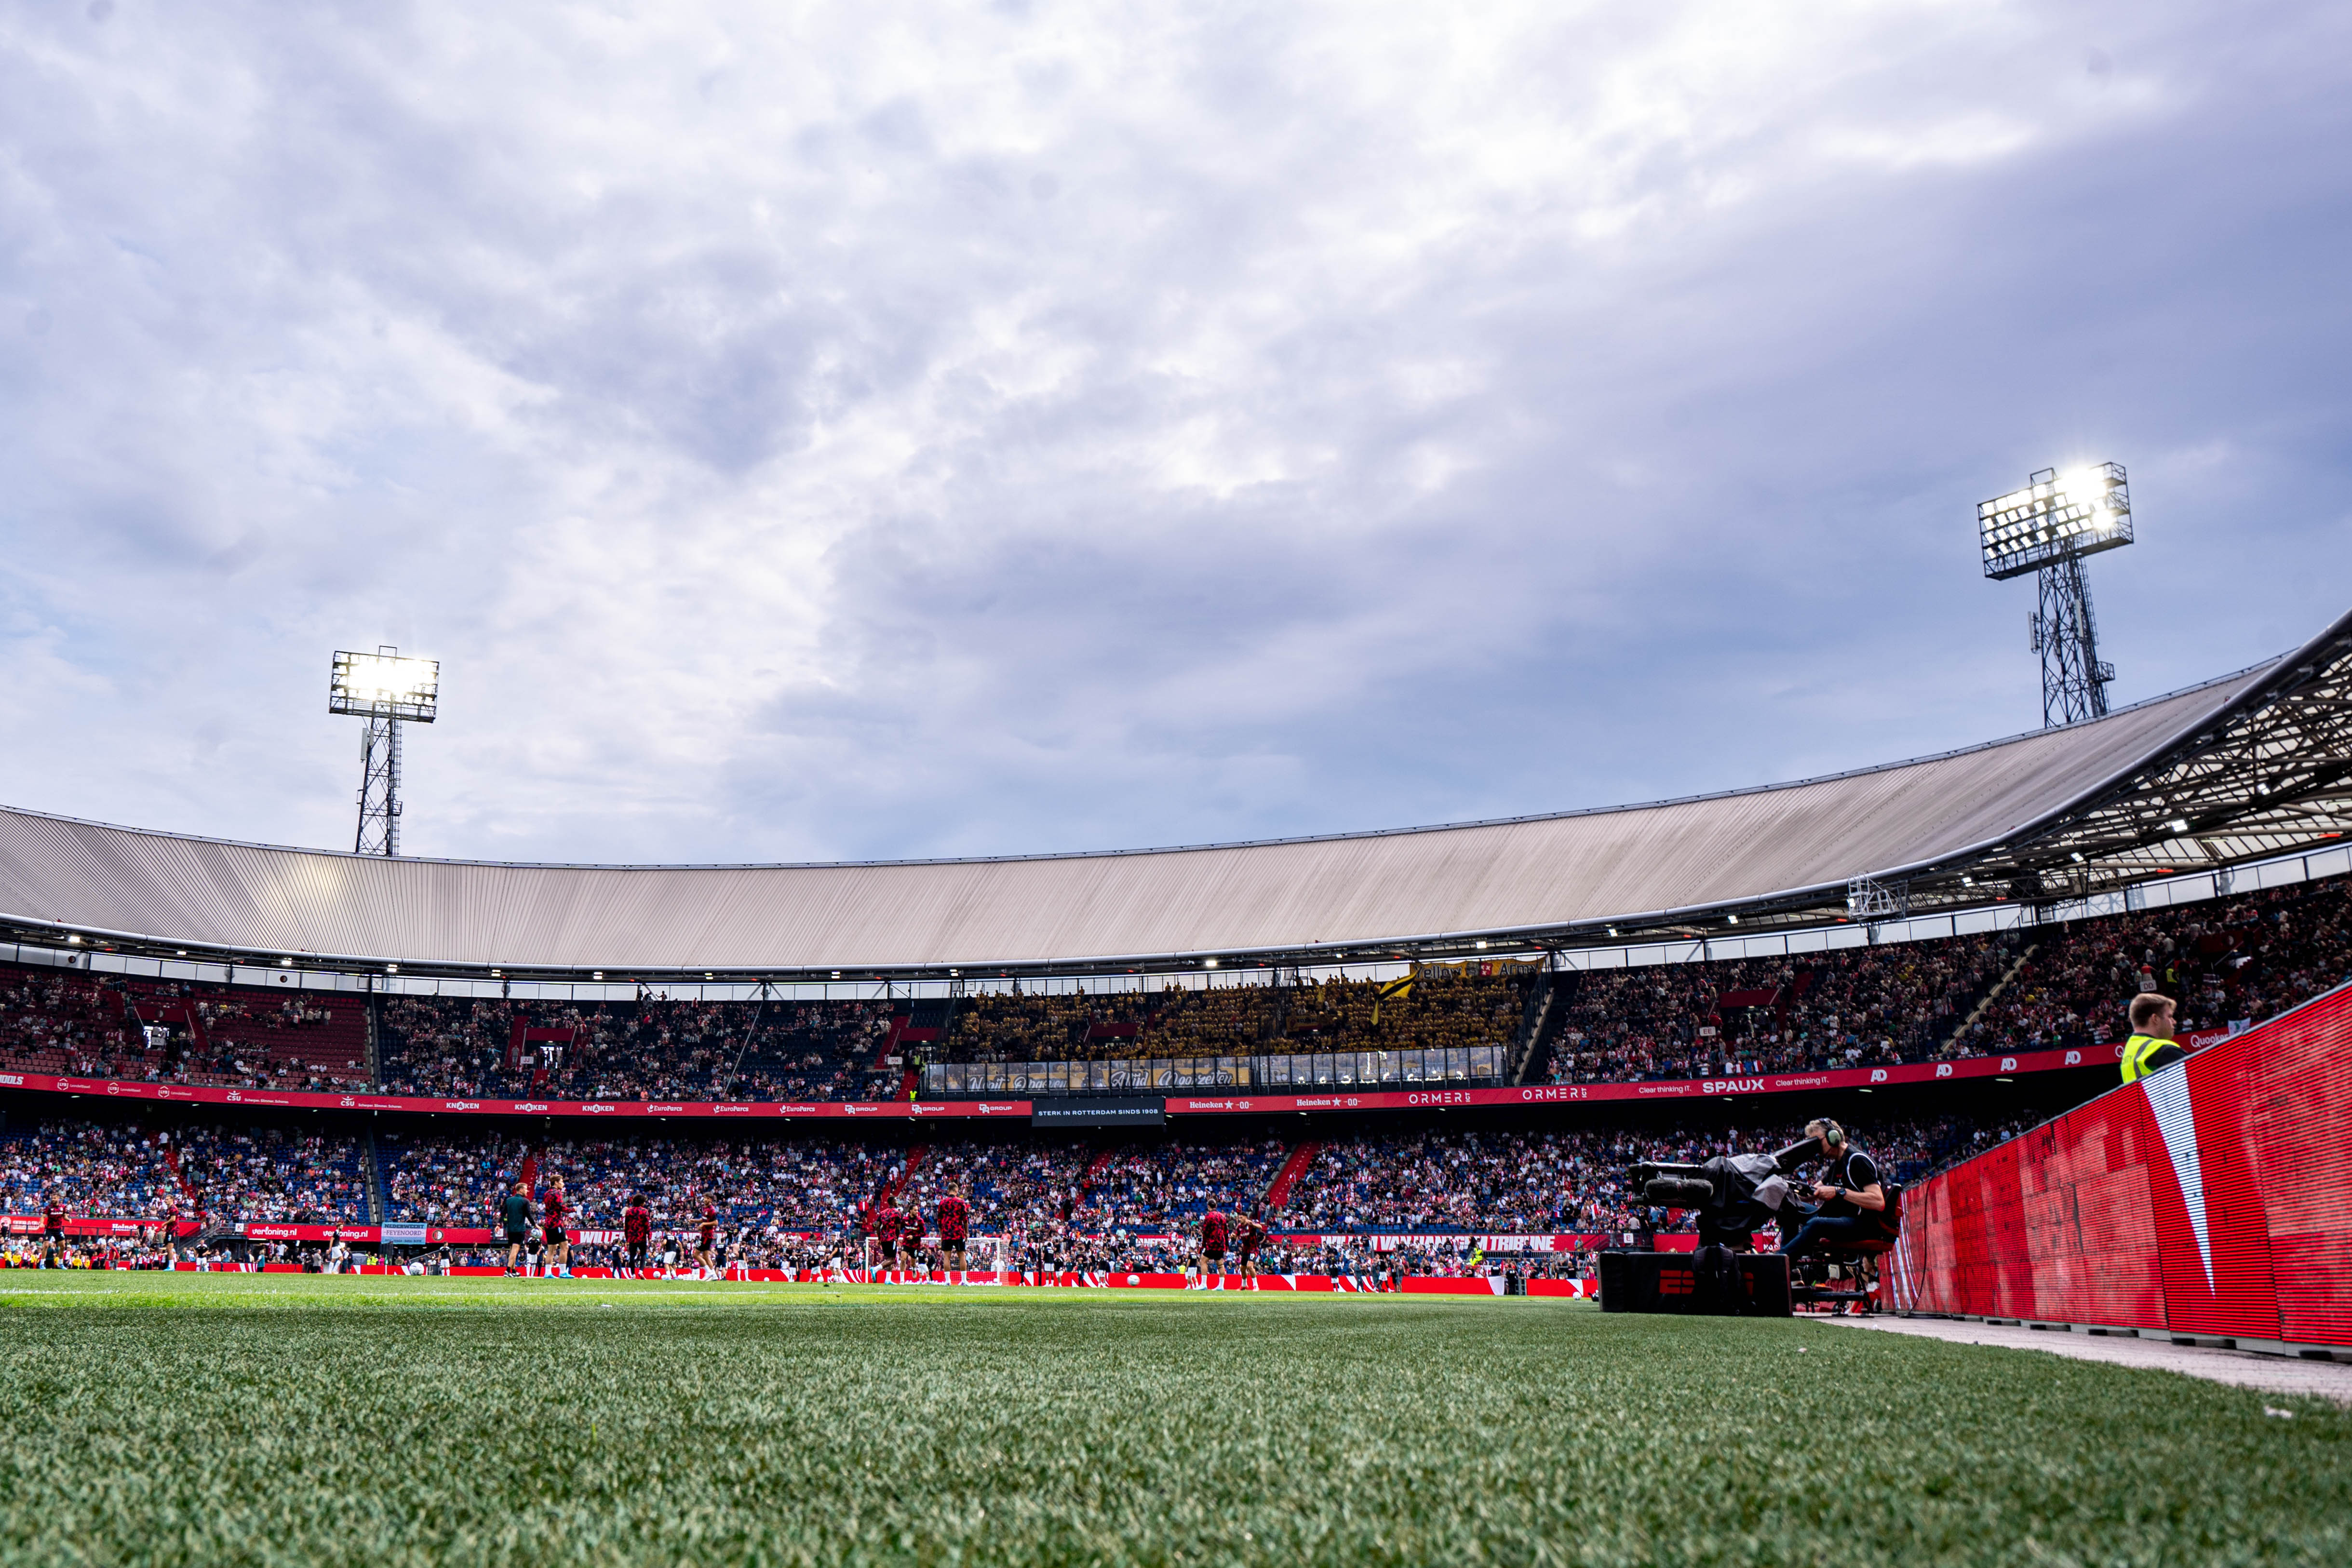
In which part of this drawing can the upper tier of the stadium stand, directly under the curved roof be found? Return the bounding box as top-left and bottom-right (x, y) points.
(0, 877), (2352, 1100)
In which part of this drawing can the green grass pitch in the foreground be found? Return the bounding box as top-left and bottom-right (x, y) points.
(0, 1272), (2352, 1568)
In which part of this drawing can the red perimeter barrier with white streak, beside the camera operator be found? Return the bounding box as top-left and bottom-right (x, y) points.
(1882, 985), (2352, 1347)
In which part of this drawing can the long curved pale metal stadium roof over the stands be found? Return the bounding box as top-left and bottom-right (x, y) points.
(0, 614), (2352, 978)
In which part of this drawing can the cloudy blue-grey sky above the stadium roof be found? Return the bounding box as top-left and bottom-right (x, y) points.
(0, 0), (2352, 860)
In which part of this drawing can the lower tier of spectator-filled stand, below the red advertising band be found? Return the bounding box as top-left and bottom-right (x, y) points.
(0, 1114), (1976, 1267)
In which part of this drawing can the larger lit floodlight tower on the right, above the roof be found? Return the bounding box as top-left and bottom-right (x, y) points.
(1976, 463), (2131, 729)
